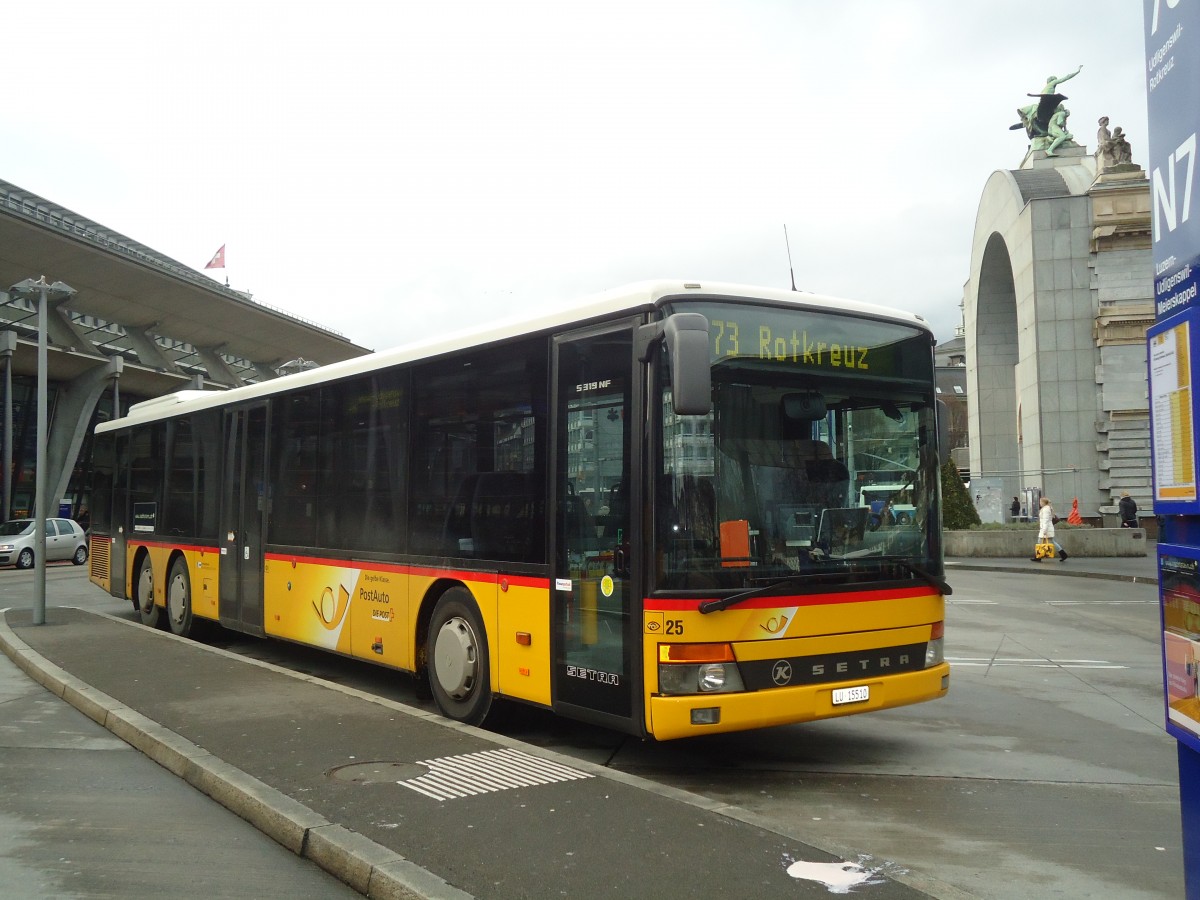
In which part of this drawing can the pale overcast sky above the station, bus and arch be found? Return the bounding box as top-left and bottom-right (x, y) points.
(7, 0), (1146, 349)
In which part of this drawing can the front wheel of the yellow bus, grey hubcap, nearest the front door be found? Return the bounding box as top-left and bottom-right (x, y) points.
(428, 588), (492, 725)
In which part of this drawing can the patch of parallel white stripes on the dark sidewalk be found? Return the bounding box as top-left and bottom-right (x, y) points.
(396, 750), (593, 800)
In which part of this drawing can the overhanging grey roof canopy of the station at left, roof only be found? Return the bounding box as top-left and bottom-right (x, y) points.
(0, 180), (368, 396)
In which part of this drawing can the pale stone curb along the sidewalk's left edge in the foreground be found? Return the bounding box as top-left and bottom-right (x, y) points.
(0, 610), (474, 900)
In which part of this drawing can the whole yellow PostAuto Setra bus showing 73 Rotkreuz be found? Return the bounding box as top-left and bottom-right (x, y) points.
(90, 282), (949, 739)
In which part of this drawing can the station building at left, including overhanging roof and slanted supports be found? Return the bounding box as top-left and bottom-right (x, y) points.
(0, 181), (367, 520)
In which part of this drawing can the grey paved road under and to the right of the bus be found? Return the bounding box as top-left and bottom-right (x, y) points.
(0, 557), (1182, 900)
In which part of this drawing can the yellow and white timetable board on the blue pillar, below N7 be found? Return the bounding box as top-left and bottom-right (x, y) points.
(1146, 308), (1200, 515)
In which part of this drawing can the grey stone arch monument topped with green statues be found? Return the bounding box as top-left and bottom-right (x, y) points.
(962, 82), (1154, 524)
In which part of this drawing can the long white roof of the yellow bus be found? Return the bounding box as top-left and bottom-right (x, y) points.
(96, 281), (929, 432)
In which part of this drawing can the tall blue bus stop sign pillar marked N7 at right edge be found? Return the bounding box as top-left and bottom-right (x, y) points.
(1142, 0), (1200, 898)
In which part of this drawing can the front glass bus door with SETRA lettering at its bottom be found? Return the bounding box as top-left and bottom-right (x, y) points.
(551, 323), (641, 731)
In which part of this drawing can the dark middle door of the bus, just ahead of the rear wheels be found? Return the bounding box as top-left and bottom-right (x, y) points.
(218, 403), (269, 635)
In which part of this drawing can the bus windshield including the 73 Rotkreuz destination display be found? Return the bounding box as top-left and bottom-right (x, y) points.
(654, 302), (941, 590)
